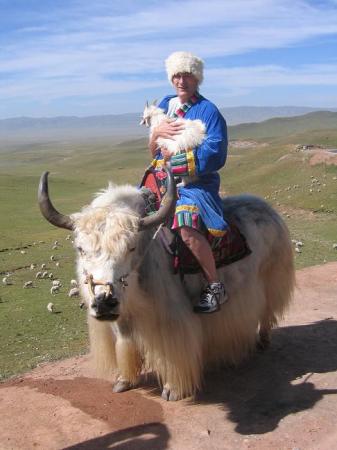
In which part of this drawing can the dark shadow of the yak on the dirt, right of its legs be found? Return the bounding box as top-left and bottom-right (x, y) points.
(196, 319), (337, 434)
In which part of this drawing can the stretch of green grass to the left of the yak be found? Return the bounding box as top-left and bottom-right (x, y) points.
(0, 138), (148, 379)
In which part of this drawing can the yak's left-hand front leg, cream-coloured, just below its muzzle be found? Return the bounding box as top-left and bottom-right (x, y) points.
(113, 326), (141, 392)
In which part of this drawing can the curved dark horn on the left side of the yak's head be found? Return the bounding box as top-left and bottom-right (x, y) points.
(37, 172), (74, 230)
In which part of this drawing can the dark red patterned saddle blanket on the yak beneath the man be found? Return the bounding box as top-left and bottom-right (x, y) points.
(140, 167), (251, 275)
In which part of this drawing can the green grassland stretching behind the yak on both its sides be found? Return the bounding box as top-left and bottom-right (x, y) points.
(0, 115), (337, 378)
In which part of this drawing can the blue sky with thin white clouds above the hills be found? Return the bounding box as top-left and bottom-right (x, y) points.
(0, 0), (337, 118)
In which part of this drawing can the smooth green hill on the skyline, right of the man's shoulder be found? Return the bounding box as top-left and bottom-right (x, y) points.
(229, 111), (337, 139)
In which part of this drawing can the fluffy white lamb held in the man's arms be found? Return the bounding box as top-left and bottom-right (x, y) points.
(140, 103), (206, 184)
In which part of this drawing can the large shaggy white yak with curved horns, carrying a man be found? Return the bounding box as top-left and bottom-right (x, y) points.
(38, 169), (295, 400)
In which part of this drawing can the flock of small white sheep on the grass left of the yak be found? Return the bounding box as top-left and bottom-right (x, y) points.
(2, 235), (83, 312)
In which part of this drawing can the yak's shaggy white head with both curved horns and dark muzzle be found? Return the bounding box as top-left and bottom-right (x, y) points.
(38, 170), (176, 321)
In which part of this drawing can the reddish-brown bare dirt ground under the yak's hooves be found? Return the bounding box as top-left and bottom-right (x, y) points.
(0, 263), (337, 450)
